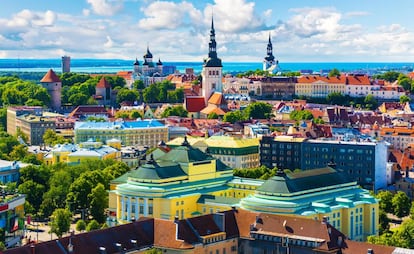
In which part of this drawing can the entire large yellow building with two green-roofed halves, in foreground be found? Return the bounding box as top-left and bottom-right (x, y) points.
(109, 139), (378, 240)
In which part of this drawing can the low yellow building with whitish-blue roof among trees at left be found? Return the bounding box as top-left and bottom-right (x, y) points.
(43, 141), (121, 165)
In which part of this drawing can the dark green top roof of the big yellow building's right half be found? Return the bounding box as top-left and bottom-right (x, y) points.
(257, 167), (353, 194)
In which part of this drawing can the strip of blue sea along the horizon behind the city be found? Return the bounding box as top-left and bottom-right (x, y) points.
(0, 59), (414, 74)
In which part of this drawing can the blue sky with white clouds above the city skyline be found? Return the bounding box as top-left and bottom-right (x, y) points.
(0, 0), (414, 63)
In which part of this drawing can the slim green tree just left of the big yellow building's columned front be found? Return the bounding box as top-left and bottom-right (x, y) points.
(88, 183), (108, 223)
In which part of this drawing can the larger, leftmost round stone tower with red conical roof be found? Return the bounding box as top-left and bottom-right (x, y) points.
(40, 69), (62, 111)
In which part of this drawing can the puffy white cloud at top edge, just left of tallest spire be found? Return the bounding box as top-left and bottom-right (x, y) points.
(138, 1), (201, 30)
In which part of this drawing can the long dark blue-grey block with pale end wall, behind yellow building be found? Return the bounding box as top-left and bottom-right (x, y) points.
(260, 136), (391, 190)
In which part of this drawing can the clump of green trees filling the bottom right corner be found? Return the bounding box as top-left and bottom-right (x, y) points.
(368, 191), (414, 249)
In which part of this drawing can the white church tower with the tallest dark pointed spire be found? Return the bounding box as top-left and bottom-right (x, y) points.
(201, 18), (223, 104)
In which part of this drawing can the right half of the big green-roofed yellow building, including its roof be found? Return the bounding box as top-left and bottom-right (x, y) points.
(240, 167), (379, 241)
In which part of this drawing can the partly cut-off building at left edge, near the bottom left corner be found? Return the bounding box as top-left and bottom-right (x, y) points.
(0, 194), (26, 248)
